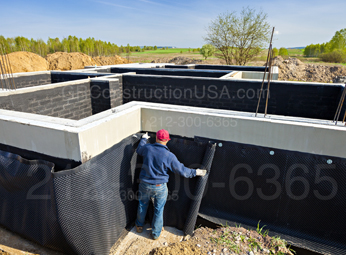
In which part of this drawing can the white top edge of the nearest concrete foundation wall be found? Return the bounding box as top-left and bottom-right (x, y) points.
(0, 101), (346, 131)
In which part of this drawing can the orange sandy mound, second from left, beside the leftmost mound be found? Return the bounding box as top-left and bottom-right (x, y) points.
(46, 52), (96, 71)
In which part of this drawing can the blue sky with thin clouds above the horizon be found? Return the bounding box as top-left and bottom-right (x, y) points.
(0, 0), (346, 48)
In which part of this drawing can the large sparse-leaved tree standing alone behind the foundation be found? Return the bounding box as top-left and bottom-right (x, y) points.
(204, 7), (270, 65)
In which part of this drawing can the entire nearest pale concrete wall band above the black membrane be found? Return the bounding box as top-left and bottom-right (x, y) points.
(0, 102), (346, 162)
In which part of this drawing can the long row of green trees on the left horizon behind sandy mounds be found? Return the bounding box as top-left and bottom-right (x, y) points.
(0, 35), (161, 57)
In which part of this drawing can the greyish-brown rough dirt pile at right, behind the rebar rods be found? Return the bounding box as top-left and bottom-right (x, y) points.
(273, 56), (346, 83)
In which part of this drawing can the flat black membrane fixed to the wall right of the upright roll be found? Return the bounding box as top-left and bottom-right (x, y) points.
(195, 137), (346, 254)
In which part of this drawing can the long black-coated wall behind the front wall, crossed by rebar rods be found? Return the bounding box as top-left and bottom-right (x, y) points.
(123, 75), (343, 120)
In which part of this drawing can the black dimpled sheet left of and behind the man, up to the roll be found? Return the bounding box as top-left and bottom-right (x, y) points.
(0, 134), (215, 254)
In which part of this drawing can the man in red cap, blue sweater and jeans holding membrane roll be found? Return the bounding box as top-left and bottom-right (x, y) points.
(136, 129), (206, 240)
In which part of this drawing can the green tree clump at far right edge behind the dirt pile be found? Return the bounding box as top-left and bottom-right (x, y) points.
(304, 28), (346, 63)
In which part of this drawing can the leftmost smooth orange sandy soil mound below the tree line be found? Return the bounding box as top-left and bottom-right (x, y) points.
(1, 51), (48, 73)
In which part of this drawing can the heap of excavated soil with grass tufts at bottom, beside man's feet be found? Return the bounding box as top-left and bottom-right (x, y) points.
(149, 227), (293, 255)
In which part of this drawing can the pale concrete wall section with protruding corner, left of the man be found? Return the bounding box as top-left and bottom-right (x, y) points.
(0, 104), (141, 162)
